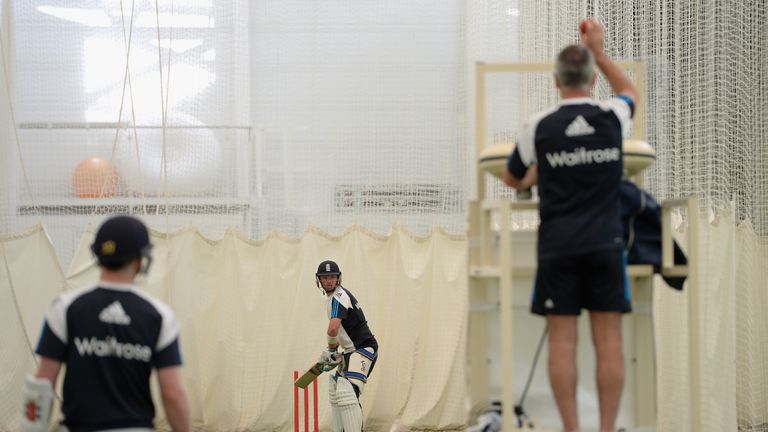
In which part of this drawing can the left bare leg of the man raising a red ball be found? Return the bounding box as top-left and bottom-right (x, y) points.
(547, 315), (579, 432)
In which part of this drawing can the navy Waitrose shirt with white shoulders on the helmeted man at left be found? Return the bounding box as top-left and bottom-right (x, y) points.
(36, 282), (181, 432)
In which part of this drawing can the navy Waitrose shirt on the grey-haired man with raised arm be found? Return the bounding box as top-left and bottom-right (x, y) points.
(507, 96), (634, 258)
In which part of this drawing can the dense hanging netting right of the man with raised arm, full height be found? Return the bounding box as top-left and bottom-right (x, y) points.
(596, 1), (768, 431)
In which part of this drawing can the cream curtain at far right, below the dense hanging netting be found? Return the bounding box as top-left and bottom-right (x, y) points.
(653, 213), (768, 432)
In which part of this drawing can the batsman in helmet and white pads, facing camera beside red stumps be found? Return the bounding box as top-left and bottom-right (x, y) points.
(315, 261), (379, 432)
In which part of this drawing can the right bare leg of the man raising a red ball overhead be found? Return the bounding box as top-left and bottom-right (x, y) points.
(590, 312), (624, 432)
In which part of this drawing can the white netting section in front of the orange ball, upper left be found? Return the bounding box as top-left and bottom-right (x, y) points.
(6, 1), (253, 266)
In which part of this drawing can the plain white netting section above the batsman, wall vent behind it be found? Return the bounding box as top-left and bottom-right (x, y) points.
(251, 0), (466, 240)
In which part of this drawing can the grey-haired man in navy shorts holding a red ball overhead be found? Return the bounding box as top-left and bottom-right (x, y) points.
(502, 18), (638, 432)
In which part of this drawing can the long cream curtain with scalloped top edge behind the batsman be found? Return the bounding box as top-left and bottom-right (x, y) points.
(0, 227), (468, 431)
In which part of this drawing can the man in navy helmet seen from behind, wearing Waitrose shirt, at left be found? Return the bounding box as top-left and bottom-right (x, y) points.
(22, 216), (190, 432)
